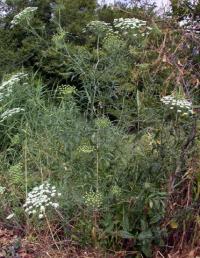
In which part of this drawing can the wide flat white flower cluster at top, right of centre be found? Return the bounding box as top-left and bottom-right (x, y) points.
(113, 18), (152, 36)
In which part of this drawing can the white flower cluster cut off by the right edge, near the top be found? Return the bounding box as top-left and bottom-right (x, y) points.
(179, 16), (200, 34)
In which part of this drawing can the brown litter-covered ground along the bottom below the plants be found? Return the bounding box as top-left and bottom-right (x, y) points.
(0, 226), (200, 258)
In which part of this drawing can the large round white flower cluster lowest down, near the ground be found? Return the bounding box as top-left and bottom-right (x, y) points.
(23, 182), (61, 219)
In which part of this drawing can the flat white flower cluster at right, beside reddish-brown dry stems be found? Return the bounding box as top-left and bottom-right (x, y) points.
(161, 95), (193, 115)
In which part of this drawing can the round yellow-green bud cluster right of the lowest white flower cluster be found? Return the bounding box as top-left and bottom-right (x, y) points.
(83, 191), (103, 209)
